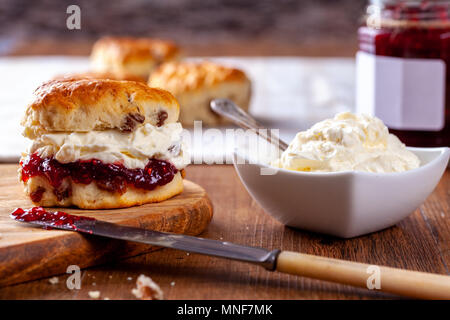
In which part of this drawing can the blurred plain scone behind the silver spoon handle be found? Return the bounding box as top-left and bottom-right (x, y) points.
(149, 61), (251, 126)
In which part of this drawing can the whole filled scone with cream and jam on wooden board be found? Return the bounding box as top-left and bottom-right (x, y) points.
(19, 79), (189, 209)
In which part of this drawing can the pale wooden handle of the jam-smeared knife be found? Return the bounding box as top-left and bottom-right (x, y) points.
(276, 251), (450, 299)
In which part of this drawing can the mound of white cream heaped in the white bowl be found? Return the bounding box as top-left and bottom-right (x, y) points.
(272, 112), (420, 172)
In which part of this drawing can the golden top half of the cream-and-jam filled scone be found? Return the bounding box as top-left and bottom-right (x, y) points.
(21, 78), (180, 139)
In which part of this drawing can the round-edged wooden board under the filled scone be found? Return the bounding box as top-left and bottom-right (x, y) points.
(0, 165), (212, 286)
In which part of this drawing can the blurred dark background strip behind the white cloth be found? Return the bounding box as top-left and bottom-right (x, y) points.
(0, 0), (366, 56)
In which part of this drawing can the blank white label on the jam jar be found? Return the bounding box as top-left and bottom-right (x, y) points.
(356, 51), (445, 131)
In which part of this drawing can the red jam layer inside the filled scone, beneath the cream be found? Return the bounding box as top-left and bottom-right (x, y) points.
(20, 153), (178, 197)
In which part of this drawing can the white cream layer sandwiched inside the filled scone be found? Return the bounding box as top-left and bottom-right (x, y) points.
(29, 123), (189, 170)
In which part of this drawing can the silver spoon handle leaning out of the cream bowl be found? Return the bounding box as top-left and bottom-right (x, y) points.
(211, 99), (288, 151)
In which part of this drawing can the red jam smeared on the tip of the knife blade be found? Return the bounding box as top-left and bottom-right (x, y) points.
(11, 207), (95, 231)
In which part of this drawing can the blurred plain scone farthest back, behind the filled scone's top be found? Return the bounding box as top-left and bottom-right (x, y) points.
(91, 37), (180, 81)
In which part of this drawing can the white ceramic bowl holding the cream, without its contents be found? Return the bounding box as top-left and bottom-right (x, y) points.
(233, 148), (450, 238)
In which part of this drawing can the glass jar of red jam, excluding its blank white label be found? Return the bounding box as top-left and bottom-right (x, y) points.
(358, 0), (450, 147)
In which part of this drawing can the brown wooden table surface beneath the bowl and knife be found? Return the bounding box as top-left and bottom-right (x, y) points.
(0, 165), (450, 299)
